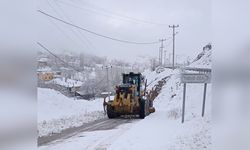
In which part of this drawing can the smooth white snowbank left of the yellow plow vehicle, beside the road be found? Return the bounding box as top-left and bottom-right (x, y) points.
(37, 88), (105, 136)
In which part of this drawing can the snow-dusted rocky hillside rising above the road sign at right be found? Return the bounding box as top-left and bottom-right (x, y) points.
(189, 44), (212, 68)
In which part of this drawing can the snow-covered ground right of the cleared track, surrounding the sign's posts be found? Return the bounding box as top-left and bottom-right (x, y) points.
(39, 69), (211, 150)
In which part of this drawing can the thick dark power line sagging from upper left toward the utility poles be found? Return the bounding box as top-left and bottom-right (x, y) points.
(37, 10), (159, 44)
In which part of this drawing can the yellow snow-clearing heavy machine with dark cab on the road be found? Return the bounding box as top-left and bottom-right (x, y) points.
(104, 72), (155, 119)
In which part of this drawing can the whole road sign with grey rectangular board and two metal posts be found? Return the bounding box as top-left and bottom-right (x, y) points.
(181, 73), (211, 123)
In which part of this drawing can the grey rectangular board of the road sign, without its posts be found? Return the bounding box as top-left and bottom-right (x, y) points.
(181, 73), (211, 83)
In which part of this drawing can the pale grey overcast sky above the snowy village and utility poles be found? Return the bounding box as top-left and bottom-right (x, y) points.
(37, 0), (211, 61)
